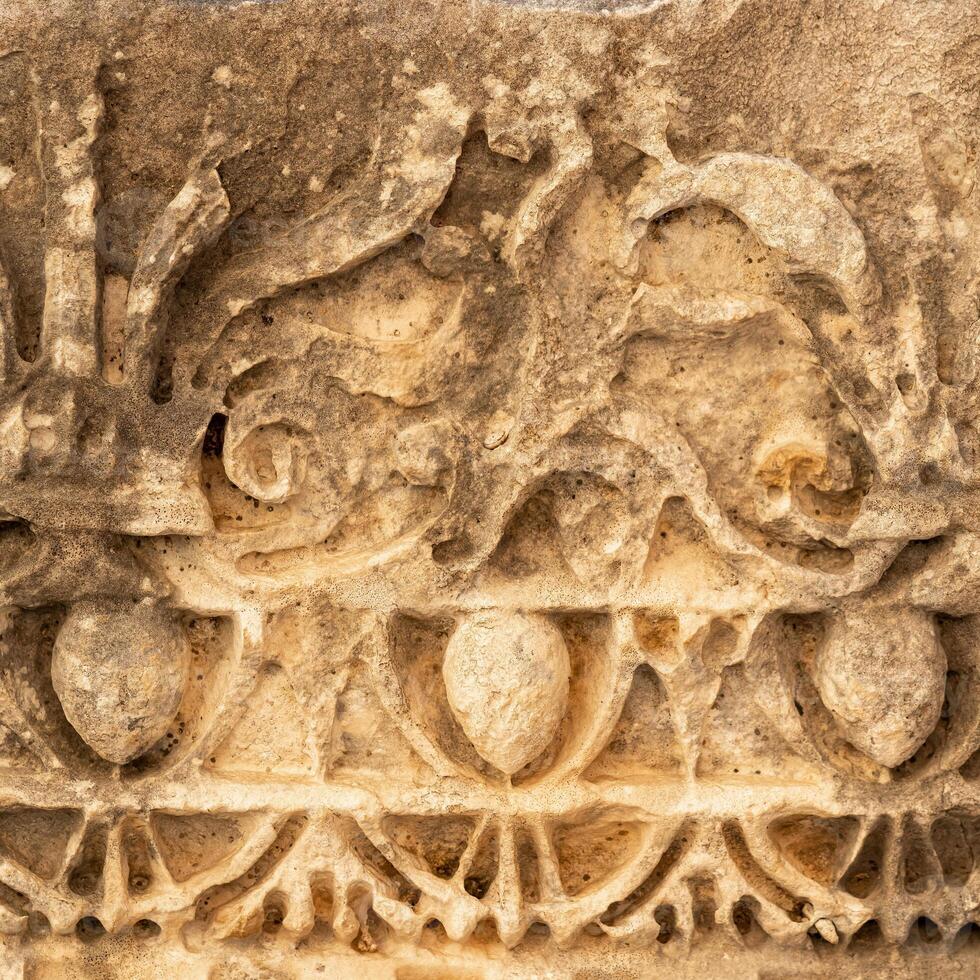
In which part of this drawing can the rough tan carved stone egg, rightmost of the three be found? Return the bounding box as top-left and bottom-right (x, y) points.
(814, 609), (946, 767)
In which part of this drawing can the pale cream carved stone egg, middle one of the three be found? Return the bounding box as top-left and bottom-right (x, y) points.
(442, 611), (571, 775)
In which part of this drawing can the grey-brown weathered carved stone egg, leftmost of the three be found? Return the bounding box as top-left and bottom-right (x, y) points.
(51, 602), (190, 764)
